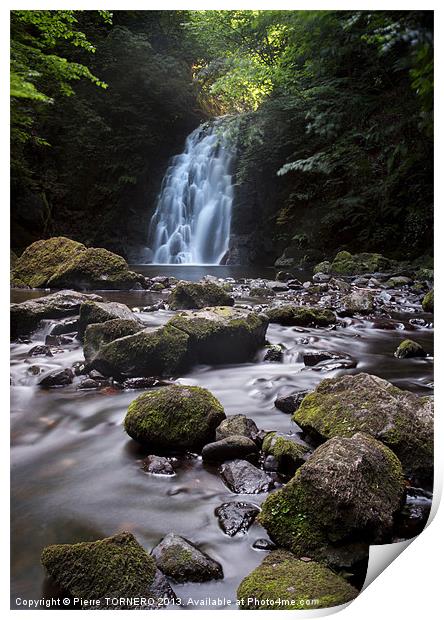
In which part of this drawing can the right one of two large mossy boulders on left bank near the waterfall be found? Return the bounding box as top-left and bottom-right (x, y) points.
(47, 248), (144, 290)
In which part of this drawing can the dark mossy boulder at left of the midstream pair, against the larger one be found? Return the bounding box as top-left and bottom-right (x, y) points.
(91, 325), (189, 378)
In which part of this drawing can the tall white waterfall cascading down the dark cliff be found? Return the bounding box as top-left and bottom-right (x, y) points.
(148, 119), (234, 265)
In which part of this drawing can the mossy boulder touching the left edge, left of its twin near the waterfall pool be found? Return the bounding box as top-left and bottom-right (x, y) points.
(12, 237), (86, 288)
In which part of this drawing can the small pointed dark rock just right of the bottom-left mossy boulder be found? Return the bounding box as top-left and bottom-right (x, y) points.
(151, 533), (224, 583)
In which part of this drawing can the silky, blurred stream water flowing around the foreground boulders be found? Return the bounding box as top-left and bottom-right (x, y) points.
(11, 284), (433, 608)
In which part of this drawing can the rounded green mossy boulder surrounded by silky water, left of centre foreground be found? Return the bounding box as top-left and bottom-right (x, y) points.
(124, 385), (225, 450)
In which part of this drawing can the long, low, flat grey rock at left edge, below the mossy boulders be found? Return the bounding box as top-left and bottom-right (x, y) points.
(11, 291), (102, 338)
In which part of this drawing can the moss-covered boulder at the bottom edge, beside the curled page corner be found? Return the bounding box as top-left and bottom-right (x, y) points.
(237, 549), (358, 610)
